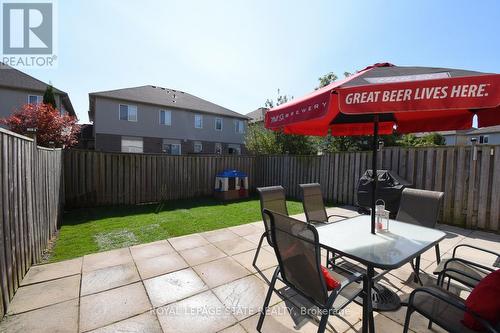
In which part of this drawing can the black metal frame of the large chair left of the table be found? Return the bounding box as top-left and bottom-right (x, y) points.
(257, 209), (367, 333)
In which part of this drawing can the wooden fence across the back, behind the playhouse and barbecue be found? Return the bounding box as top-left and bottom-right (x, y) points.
(64, 145), (500, 232)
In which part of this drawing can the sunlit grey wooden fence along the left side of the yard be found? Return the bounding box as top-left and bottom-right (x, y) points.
(0, 128), (63, 317)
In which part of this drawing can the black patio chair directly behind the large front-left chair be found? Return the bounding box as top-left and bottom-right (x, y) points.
(252, 186), (288, 269)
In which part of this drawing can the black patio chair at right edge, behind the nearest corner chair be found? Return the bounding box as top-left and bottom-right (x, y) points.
(433, 244), (500, 290)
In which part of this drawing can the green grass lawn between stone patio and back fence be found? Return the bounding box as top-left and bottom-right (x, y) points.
(48, 198), (302, 262)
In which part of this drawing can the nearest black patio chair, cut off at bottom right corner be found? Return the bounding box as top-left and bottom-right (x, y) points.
(403, 286), (499, 333)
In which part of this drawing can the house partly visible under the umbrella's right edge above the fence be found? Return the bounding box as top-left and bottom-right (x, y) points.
(416, 126), (500, 146)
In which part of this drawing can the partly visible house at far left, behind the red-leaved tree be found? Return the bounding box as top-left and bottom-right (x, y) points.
(0, 62), (76, 119)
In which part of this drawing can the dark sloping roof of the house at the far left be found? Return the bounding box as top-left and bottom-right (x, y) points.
(0, 62), (76, 116)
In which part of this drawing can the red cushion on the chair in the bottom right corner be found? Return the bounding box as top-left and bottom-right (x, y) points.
(462, 269), (500, 331)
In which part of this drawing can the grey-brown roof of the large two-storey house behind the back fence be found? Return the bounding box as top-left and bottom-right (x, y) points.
(89, 86), (249, 120)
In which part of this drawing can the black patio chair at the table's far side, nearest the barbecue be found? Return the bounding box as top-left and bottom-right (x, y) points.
(299, 183), (348, 224)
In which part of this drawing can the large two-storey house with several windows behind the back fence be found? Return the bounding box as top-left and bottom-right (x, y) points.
(89, 86), (248, 155)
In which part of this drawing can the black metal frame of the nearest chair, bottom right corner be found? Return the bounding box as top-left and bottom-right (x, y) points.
(403, 270), (499, 333)
